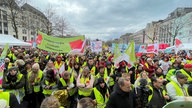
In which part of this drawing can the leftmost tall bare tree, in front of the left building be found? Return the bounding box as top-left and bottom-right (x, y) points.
(0, 0), (25, 38)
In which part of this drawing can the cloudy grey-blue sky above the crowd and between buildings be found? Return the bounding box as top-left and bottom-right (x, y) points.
(29, 0), (192, 40)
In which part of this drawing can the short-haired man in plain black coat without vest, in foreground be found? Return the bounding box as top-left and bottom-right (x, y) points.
(106, 77), (135, 108)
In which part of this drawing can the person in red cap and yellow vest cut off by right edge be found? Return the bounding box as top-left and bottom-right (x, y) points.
(180, 64), (192, 83)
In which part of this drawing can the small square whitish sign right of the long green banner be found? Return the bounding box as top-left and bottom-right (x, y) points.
(90, 41), (102, 52)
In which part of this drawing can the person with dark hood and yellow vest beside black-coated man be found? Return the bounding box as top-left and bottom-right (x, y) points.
(91, 78), (110, 108)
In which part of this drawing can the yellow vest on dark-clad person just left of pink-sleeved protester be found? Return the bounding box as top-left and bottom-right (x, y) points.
(59, 73), (75, 96)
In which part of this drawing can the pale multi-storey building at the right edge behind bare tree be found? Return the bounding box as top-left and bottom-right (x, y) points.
(158, 8), (192, 45)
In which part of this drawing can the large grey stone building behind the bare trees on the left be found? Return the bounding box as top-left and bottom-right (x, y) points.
(0, 0), (51, 41)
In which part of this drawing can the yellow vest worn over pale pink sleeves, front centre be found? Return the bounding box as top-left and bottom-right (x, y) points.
(78, 76), (92, 96)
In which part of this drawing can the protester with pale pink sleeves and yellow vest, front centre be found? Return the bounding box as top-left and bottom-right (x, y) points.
(77, 67), (94, 99)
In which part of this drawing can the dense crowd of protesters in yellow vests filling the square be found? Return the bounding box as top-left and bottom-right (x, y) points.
(0, 47), (192, 108)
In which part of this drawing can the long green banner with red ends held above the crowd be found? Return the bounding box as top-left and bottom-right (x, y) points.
(36, 32), (84, 53)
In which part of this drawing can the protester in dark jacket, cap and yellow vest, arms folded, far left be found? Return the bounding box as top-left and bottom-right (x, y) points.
(2, 67), (25, 102)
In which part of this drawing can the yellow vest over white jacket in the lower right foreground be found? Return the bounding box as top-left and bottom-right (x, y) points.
(166, 81), (189, 96)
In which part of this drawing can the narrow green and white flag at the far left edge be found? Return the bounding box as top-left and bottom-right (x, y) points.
(0, 44), (9, 88)
